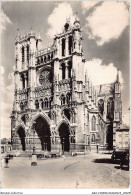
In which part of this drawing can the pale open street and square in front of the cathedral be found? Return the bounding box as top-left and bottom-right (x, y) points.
(1, 153), (129, 189)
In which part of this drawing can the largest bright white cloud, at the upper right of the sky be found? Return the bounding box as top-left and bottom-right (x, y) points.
(86, 1), (129, 45)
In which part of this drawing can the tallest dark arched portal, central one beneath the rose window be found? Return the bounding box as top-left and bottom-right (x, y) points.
(35, 116), (51, 151)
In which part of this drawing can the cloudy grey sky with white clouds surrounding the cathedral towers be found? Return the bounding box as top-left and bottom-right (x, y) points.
(1, 1), (130, 138)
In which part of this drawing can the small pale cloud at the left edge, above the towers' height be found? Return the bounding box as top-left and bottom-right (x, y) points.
(1, 10), (12, 31)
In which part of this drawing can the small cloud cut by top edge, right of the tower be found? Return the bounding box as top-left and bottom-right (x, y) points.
(81, 1), (100, 14)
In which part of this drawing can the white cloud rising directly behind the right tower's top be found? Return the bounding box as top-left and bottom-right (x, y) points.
(46, 2), (74, 38)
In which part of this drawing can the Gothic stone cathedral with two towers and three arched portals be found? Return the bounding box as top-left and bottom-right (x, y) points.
(10, 15), (122, 153)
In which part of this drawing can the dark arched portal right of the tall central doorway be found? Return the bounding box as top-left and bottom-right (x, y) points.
(59, 123), (70, 151)
